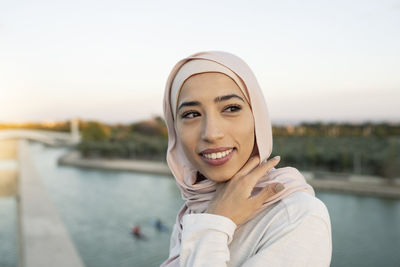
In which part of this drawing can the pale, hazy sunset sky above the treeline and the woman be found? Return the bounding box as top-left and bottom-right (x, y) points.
(0, 0), (400, 123)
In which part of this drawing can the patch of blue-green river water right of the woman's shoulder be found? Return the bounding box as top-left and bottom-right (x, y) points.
(318, 193), (400, 266)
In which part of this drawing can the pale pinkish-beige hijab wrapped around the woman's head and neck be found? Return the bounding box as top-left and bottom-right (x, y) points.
(161, 51), (314, 266)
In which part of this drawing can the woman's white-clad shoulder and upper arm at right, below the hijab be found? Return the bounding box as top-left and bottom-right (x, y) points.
(238, 194), (332, 267)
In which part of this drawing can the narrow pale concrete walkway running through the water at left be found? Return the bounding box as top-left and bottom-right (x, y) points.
(18, 140), (84, 267)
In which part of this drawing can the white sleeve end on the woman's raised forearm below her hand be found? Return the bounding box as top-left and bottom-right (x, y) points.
(180, 213), (236, 267)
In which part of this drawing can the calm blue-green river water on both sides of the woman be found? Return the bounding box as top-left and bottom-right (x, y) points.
(0, 143), (400, 267)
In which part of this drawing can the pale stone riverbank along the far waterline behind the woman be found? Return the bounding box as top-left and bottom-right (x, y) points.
(58, 151), (400, 199)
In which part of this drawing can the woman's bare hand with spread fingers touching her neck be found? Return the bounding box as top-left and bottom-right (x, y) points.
(206, 156), (284, 226)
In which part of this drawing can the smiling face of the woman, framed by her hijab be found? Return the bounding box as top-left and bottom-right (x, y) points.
(175, 73), (254, 182)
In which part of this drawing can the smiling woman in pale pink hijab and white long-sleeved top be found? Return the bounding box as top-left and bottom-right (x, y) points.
(162, 52), (332, 266)
